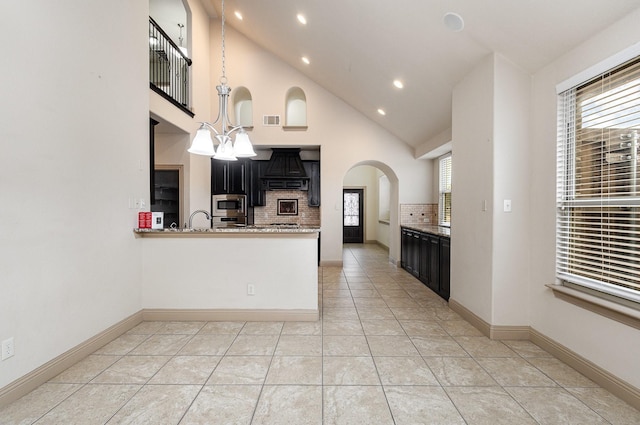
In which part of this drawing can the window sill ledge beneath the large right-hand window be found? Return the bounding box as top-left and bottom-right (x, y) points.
(546, 285), (640, 329)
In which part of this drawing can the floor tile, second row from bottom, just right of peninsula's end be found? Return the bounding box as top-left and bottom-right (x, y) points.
(322, 356), (380, 385)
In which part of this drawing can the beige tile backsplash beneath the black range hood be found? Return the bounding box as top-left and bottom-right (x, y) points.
(253, 190), (320, 226)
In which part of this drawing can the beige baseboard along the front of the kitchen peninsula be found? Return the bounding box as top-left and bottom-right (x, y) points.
(142, 309), (320, 322)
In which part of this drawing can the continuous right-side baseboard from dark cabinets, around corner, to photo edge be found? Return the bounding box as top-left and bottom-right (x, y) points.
(449, 298), (640, 410)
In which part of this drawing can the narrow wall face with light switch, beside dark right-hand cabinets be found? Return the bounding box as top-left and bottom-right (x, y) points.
(451, 55), (494, 322)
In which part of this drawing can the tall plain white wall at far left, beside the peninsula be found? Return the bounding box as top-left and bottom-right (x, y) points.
(0, 0), (149, 387)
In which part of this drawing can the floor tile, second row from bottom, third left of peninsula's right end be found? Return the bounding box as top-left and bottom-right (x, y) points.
(149, 356), (221, 385)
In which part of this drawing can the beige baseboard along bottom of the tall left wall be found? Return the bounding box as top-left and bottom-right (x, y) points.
(0, 311), (143, 407)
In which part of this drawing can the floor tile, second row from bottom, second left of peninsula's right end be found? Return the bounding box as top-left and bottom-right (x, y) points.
(207, 356), (271, 385)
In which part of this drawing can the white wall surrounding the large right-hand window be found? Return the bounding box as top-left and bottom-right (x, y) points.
(529, 9), (640, 388)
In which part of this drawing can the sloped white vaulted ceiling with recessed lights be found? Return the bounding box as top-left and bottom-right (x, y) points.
(161, 0), (640, 146)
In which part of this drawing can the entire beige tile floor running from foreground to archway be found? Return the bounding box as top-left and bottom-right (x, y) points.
(0, 245), (640, 425)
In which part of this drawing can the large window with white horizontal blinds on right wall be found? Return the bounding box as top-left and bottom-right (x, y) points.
(556, 58), (640, 302)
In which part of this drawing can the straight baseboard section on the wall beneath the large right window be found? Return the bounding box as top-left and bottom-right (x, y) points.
(529, 329), (640, 409)
